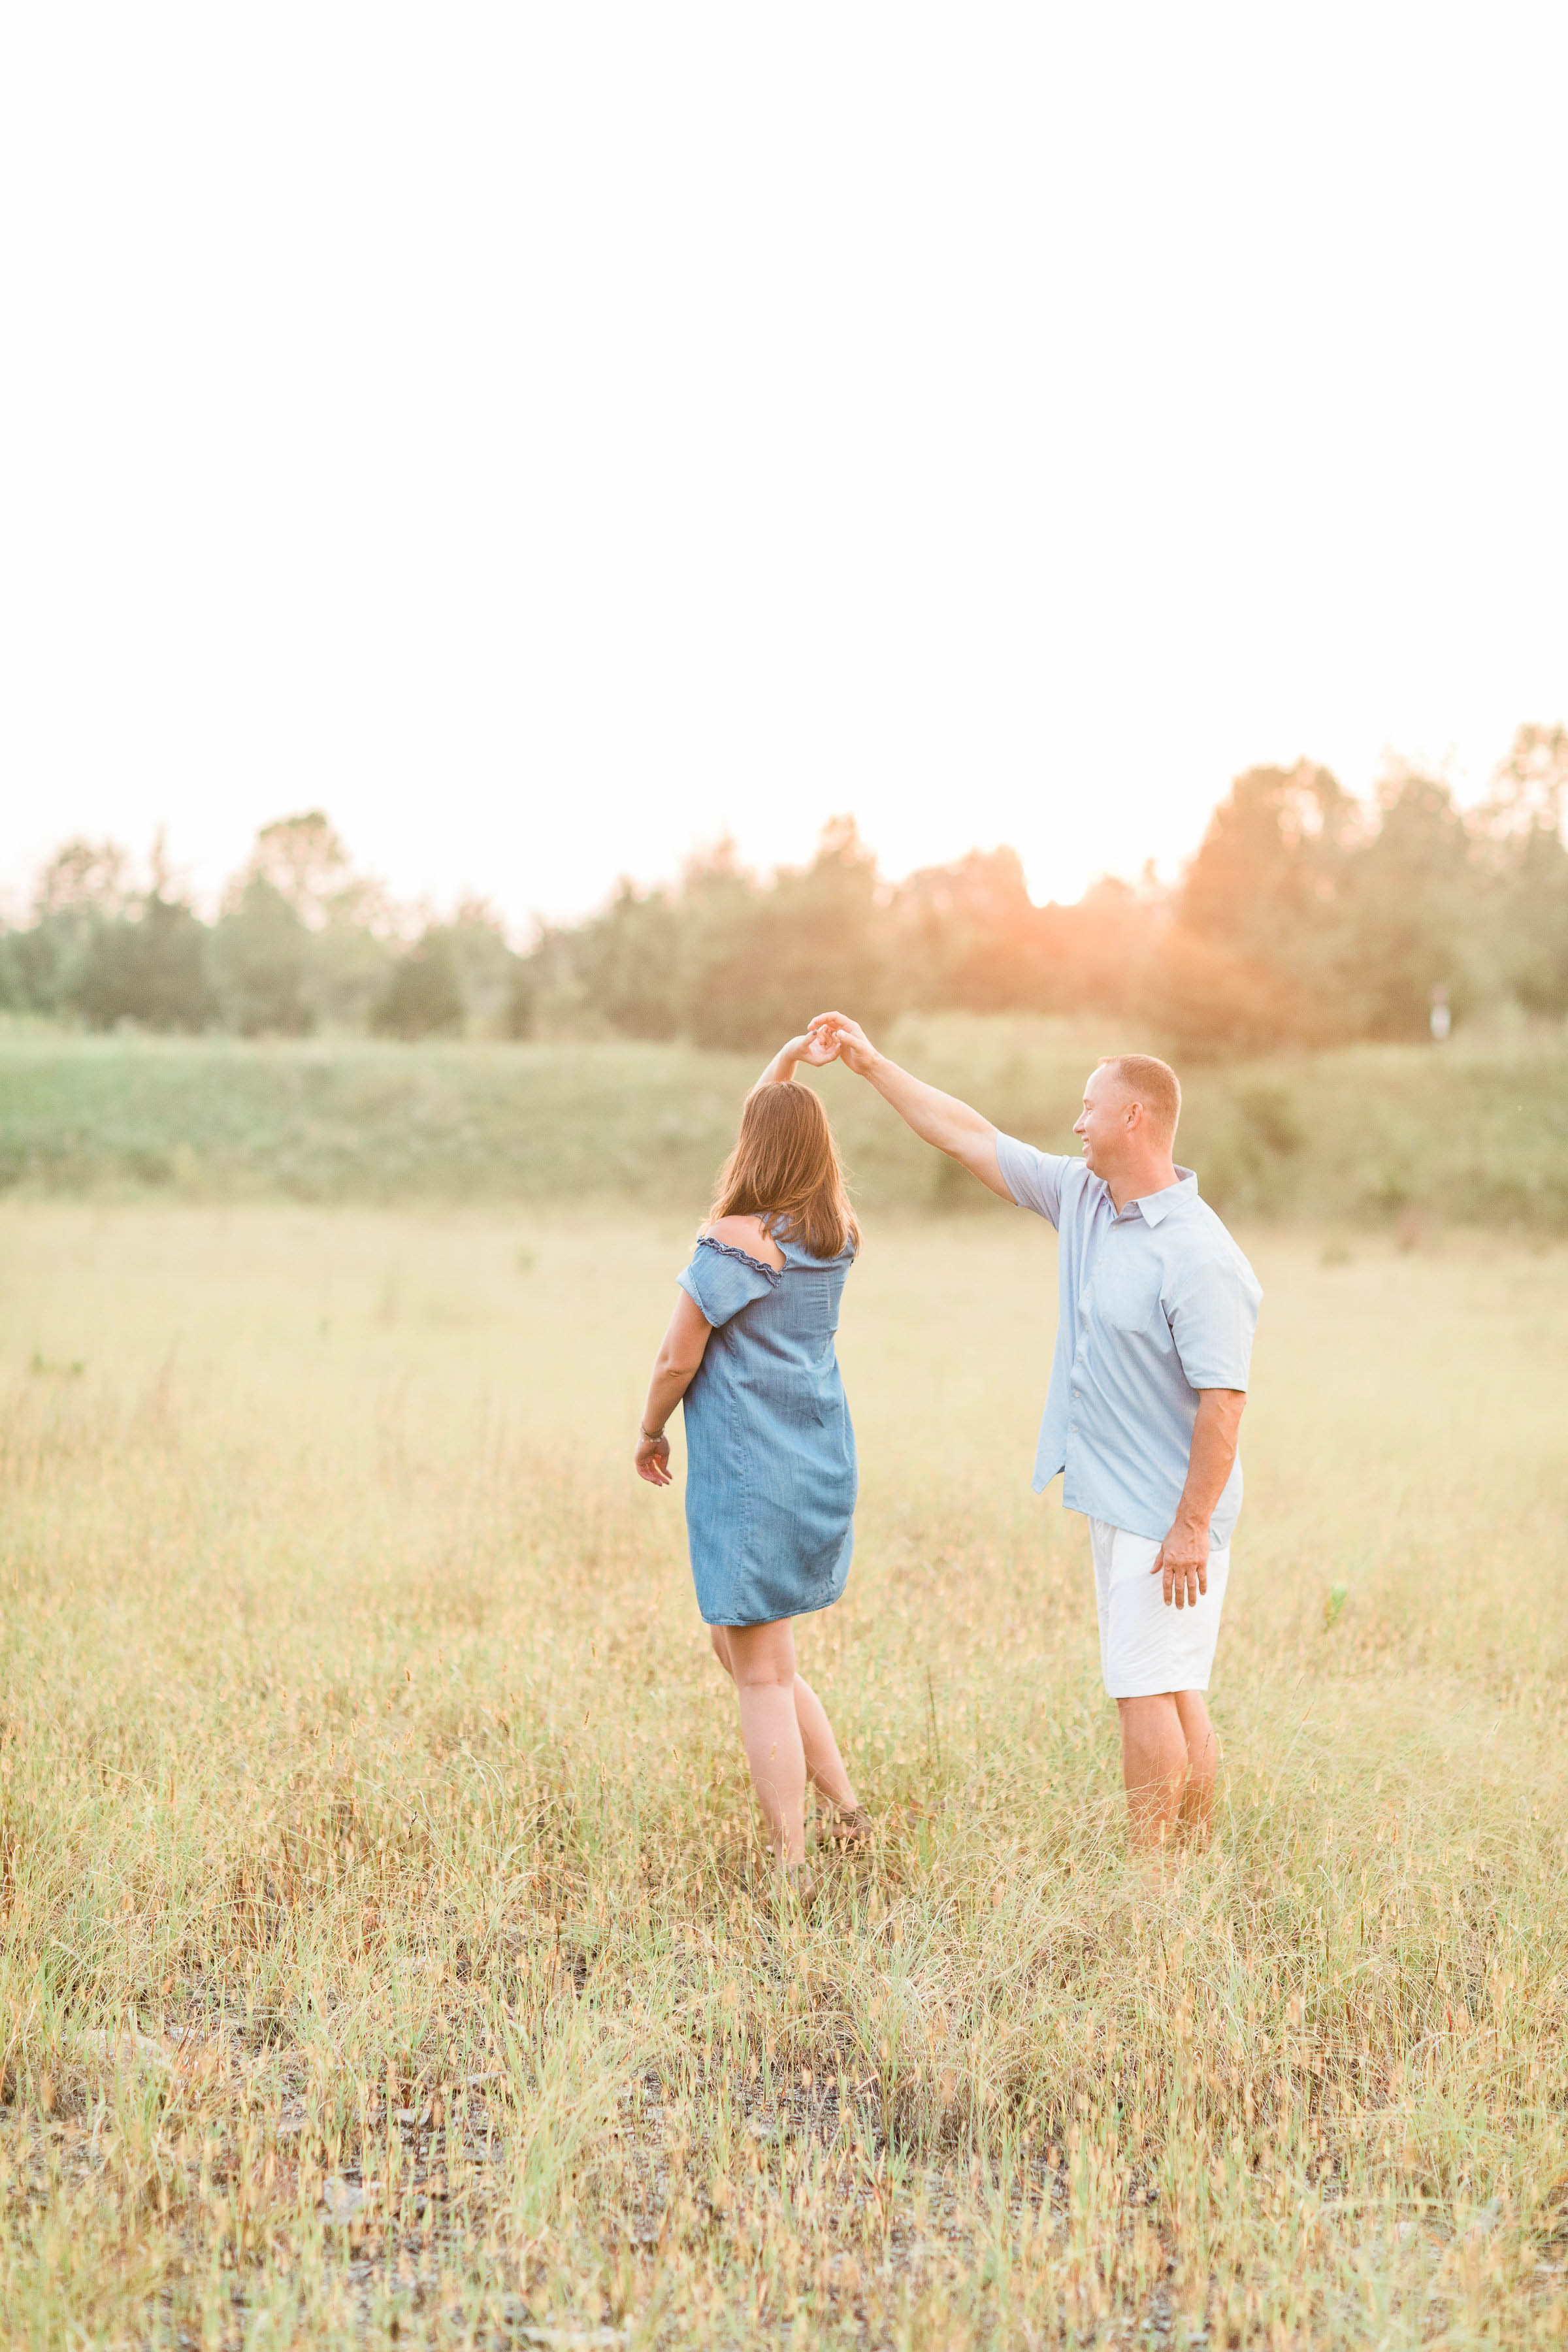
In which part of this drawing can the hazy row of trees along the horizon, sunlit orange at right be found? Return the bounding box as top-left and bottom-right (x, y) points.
(0, 727), (1568, 1054)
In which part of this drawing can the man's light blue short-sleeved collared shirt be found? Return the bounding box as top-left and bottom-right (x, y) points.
(997, 1134), (1262, 1550)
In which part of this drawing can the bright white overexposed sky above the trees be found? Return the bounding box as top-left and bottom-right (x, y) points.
(0, 0), (1568, 922)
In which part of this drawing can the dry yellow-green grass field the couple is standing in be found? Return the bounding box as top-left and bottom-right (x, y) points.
(0, 1202), (1568, 2352)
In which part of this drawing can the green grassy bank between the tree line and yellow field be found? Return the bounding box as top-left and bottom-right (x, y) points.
(0, 1016), (1568, 1232)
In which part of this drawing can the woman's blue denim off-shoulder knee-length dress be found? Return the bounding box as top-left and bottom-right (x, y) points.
(679, 1235), (858, 1625)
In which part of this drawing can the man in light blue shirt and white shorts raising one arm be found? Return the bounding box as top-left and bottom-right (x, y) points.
(811, 1014), (1262, 1844)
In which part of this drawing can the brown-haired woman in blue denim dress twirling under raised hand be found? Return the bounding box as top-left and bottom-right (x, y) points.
(637, 1037), (870, 1879)
